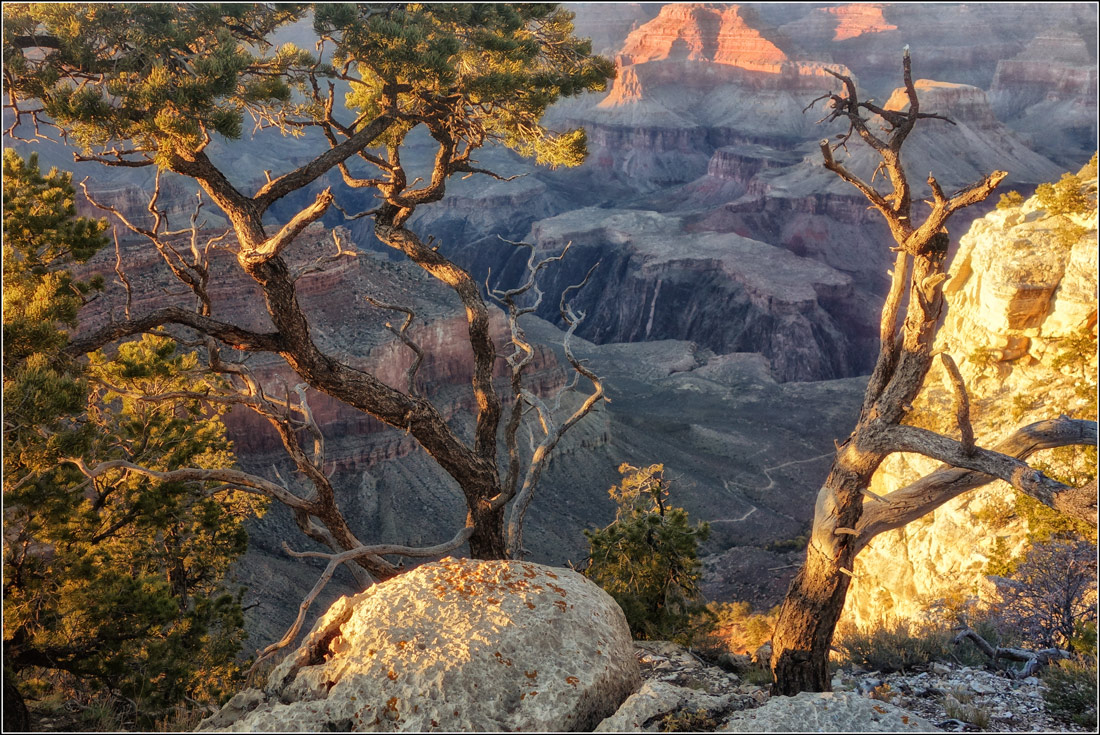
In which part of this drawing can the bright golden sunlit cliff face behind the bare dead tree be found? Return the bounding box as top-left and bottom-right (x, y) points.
(845, 169), (1097, 625)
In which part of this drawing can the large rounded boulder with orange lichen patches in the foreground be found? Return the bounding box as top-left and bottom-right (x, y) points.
(200, 558), (640, 732)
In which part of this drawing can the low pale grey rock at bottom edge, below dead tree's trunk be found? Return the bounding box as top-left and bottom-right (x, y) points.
(722, 692), (938, 733)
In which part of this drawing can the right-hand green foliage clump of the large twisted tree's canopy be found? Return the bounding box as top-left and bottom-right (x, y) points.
(315, 3), (614, 166)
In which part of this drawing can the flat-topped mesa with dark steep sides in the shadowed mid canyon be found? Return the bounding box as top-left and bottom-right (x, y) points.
(529, 209), (858, 381)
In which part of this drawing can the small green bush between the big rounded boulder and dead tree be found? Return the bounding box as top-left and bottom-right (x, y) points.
(585, 464), (710, 641)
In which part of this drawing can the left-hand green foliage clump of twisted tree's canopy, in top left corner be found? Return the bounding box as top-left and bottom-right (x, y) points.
(3, 3), (310, 155)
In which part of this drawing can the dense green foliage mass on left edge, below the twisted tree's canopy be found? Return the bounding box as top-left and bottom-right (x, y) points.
(3, 152), (259, 722)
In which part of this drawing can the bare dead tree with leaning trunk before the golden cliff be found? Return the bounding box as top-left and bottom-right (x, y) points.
(771, 50), (1097, 694)
